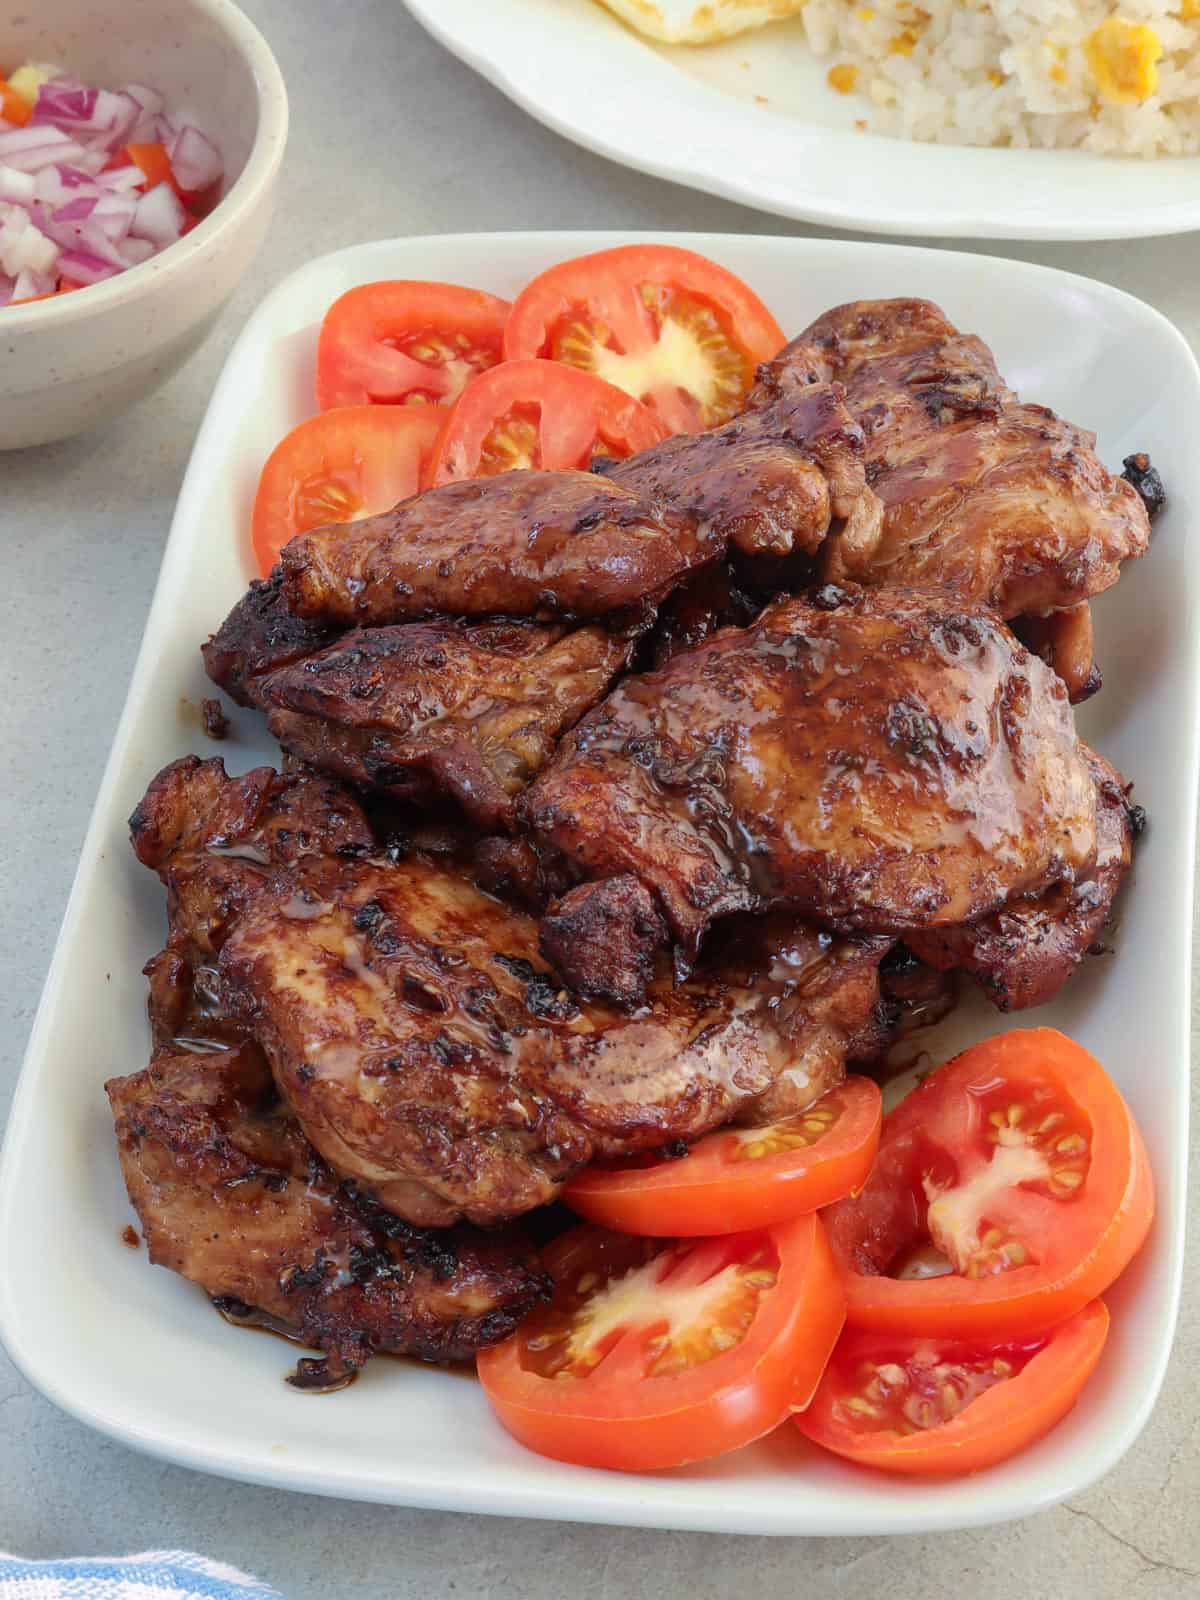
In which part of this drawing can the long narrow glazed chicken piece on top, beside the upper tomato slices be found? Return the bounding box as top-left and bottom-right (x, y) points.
(282, 472), (723, 627)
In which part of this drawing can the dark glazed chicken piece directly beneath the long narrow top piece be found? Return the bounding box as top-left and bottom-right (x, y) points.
(258, 618), (635, 829)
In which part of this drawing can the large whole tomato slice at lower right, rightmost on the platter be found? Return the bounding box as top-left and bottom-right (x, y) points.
(824, 1027), (1154, 1338)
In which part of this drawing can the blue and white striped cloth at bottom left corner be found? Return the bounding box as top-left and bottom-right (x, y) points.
(0, 1550), (282, 1600)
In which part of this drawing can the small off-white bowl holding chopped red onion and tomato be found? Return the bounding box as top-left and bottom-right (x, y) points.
(0, 0), (288, 450)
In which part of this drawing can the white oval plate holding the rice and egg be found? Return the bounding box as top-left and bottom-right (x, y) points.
(405, 0), (1200, 238)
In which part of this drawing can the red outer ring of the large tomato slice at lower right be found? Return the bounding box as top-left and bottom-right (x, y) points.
(822, 1029), (1154, 1338)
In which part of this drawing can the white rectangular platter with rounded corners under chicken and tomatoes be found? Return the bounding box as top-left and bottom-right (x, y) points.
(0, 234), (1200, 1534)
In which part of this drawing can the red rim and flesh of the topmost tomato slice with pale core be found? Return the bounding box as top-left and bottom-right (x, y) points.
(504, 245), (786, 434)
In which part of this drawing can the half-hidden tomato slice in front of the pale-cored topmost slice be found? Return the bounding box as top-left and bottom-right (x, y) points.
(429, 362), (662, 483)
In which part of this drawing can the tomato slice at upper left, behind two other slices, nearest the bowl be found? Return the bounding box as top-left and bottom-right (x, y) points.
(317, 278), (509, 411)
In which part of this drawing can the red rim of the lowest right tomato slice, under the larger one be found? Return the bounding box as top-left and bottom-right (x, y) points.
(795, 1301), (1109, 1477)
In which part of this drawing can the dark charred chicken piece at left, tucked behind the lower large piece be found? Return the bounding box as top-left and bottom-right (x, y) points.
(130, 755), (374, 1045)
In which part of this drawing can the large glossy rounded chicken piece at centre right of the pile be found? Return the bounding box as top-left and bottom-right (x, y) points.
(518, 587), (1096, 994)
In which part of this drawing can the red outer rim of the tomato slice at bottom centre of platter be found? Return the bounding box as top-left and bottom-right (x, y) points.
(477, 1216), (845, 1472)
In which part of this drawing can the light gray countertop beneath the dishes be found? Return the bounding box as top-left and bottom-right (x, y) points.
(0, 0), (1200, 1600)
